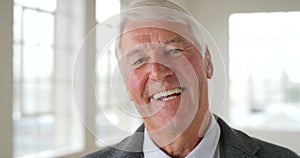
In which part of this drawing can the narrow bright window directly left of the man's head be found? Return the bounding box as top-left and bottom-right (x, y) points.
(95, 0), (141, 145)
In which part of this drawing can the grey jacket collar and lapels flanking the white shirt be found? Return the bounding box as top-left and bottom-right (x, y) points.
(115, 115), (260, 158)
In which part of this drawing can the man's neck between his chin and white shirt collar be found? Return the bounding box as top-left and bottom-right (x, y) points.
(151, 111), (211, 158)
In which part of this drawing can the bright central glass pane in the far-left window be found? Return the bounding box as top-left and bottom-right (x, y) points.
(23, 45), (54, 80)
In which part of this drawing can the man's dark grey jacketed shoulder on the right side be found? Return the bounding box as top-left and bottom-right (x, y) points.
(217, 115), (299, 158)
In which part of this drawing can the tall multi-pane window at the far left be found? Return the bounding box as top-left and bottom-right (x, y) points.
(13, 0), (81, 157)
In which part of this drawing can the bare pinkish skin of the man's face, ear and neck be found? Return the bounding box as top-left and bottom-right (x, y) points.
(120, 22), (213, 157)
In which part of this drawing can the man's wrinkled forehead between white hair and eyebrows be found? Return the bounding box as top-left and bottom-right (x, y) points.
(119, 22), (195, 54)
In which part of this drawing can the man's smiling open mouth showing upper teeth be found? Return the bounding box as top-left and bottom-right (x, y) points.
(151, 87), (184, 101)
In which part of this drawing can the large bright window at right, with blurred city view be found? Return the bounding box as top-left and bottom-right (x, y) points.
(229, 12), (300, 131)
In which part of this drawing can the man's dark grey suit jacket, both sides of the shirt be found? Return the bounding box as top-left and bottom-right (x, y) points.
(83, 115), (299, 158)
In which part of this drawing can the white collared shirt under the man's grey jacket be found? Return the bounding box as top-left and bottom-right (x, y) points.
(143, 114), (221, 158)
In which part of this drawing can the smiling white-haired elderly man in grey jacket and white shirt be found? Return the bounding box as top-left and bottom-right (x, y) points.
(86, 0), (298, 158)
